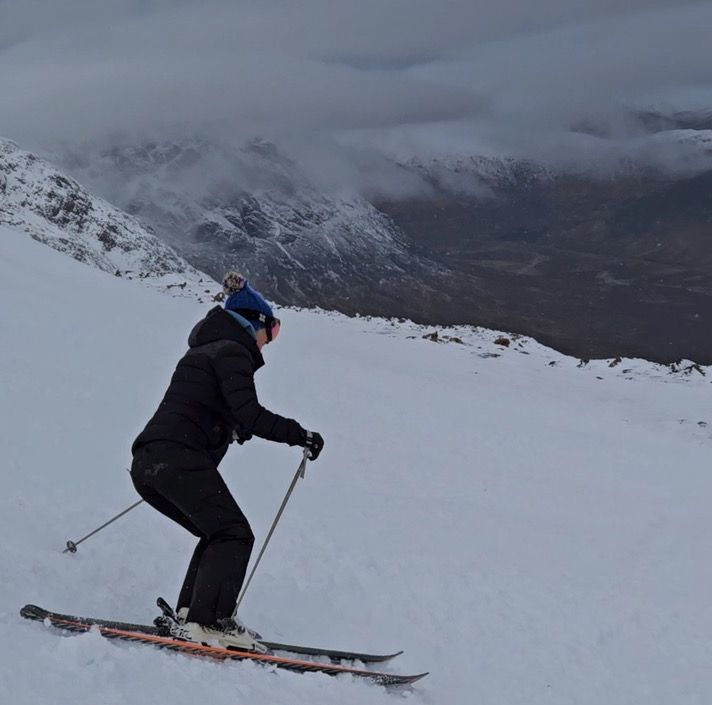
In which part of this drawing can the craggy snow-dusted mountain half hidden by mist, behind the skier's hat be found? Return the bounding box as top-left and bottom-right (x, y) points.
(66, 140), (437, 313)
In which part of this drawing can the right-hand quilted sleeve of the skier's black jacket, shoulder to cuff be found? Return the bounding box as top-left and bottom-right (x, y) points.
(213, 344), (306, 446)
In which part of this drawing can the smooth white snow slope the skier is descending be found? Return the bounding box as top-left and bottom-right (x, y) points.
(0, 226), (712, 705)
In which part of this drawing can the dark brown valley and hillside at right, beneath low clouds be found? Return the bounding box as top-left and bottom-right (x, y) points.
(377, 128), (712, 364)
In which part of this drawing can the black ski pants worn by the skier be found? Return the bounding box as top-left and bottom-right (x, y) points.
(131, 441), (255, 626)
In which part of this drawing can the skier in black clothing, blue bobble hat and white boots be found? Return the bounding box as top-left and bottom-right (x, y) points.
(131, 272), (324, 652)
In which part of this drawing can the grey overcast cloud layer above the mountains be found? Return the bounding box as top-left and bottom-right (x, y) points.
(0, 0), (712, 172)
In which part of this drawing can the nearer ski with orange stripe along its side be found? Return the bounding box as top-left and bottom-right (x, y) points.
(20, 605), (427, 686)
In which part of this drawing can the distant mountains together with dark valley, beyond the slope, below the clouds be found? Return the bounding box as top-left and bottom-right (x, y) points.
(55, 132), (712, 363)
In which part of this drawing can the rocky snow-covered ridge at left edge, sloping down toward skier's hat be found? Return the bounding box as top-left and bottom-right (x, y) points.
(0, 140), (216, 298)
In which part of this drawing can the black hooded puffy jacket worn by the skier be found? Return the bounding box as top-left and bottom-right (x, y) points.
(131, 306), (306, 464)
